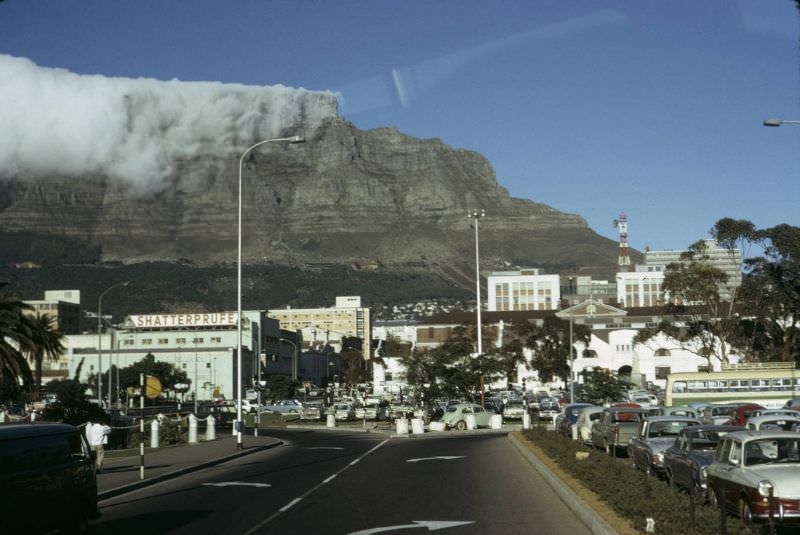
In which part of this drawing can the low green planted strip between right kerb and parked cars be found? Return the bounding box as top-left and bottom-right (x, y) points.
(524, 428), (753, 535)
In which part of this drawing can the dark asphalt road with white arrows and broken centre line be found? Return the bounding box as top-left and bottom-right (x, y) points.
(91, 431), (589, 535)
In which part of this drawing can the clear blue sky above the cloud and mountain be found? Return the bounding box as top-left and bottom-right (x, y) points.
(0, 0), (800, 250)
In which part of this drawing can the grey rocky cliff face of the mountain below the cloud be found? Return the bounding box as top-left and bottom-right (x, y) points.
(0, 118), (616, 280)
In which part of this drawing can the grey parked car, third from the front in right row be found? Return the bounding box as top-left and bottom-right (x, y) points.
(628, 416), (701, 475)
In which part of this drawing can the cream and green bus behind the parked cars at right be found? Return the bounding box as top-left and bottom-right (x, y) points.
(664, 362), (800, 408)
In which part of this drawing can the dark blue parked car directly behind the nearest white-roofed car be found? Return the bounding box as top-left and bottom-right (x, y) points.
(664, 424), (742, 495)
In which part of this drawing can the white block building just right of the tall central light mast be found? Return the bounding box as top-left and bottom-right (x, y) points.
(486, 269), (561, 312)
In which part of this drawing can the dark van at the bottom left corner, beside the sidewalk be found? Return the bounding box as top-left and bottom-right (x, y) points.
(0, 424), (98, 533)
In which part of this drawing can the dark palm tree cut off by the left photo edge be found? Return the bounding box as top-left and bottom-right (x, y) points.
(0, 283), (32, 385)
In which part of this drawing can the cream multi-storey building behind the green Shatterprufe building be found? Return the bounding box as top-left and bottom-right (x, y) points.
(268, 296), (372, 360)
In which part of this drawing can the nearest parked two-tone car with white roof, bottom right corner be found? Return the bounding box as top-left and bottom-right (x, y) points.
(706, 431), (800, 525)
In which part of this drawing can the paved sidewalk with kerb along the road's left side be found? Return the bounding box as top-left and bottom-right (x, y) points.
(97, 430), (282, 500)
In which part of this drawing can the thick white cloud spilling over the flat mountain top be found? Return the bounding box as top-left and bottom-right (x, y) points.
(0, 54), (337, 190)
